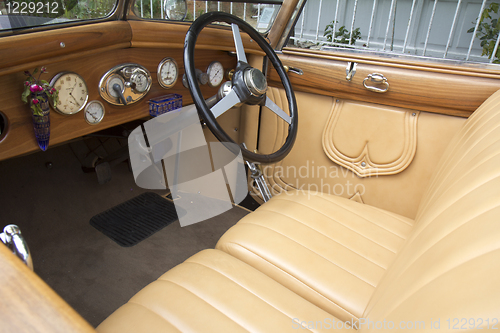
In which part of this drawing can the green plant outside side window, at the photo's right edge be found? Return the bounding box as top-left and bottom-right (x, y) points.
(467, 2), (500, 64)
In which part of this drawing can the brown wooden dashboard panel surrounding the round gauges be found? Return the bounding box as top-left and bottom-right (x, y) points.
(0, 22), (239, 160)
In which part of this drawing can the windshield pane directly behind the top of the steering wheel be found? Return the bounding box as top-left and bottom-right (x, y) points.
(134, 0), (282, 33)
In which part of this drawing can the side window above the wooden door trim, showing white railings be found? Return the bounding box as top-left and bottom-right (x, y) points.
(287, 0), (500, 63)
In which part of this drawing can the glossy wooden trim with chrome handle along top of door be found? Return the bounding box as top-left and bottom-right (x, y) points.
(270, 51), (500, 117)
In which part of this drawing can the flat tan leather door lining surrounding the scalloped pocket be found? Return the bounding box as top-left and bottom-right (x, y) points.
(252, 88), (465, 218)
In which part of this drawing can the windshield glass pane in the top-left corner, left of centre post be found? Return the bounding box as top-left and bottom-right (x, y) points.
(0, 0), (117, 30)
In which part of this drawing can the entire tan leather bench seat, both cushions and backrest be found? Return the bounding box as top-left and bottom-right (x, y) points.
(98, 92), (500, 332)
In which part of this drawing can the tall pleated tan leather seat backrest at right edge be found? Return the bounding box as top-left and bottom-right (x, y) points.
(360, 91), (500, 332)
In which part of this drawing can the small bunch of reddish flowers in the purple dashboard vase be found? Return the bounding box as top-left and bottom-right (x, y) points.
(21, 67), (59, 116)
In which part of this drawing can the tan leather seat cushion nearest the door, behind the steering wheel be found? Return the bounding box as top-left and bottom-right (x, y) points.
(217, 191), (413, 321)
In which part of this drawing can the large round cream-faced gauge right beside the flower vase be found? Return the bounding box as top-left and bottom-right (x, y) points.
(50, 72), (89, 115)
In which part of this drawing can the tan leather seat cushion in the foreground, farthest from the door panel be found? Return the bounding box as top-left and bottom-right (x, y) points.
(97, 250), (347, 333)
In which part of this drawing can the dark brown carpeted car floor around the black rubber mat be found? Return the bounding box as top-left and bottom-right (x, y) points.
(0, 138), (248, 326)
